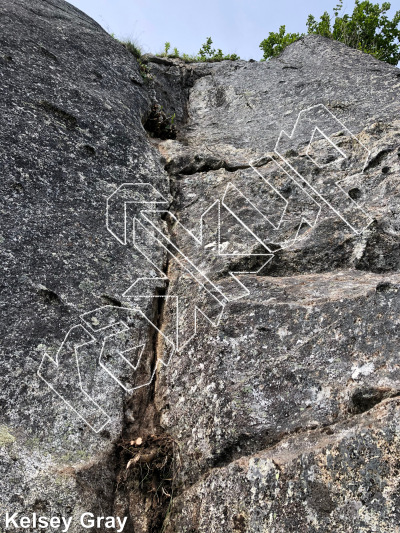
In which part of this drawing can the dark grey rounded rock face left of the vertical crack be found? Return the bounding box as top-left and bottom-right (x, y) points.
(0, 0), (168, 531)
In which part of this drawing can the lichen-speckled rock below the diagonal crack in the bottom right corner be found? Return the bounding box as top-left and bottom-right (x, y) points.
(166, 400), (399, 533)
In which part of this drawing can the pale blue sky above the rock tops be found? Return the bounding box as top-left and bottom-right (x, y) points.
(69, 0), (398, 60)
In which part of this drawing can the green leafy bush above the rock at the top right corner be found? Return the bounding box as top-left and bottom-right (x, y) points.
(260, 0), (400, 65)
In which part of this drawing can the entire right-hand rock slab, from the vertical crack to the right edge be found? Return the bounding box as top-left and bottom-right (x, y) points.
(147, 37), (400, 533)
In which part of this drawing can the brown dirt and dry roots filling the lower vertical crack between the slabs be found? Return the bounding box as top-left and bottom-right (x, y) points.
(114, 206), (179, 533)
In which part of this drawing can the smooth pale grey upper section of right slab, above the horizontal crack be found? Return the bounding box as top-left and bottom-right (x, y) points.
(180, 35), (400, 162)
